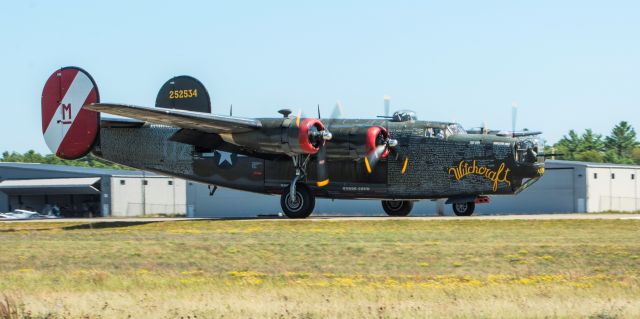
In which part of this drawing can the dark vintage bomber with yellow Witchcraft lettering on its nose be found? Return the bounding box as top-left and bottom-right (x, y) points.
(42, 67), (544, 218)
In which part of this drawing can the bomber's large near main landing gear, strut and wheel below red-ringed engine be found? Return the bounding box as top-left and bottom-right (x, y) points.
(280, 155), (316, 218)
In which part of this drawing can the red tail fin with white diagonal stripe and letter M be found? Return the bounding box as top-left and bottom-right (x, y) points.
(42, 67), (100, 159)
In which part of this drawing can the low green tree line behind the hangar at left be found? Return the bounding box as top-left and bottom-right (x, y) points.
(0, 150), (132, 170)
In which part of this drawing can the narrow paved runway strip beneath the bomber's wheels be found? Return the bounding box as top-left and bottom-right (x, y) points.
(0, 214), (640, 223)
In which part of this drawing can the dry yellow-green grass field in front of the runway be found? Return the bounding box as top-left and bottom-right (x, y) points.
(0, 219), (640, 319)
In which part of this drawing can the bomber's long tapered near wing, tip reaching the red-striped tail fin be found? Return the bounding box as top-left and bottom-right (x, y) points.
(83, 103), (262, 133)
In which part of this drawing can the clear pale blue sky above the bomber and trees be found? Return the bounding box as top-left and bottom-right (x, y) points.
(0, 0), (640, 153)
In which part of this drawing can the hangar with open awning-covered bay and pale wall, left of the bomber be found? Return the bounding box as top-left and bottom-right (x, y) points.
(0, 163), (186, 217)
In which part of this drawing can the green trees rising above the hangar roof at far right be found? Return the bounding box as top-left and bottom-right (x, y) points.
(545, 121), (640, 164)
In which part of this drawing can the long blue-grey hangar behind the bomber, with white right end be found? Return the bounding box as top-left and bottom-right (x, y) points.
(187, 160), (640, 217)
